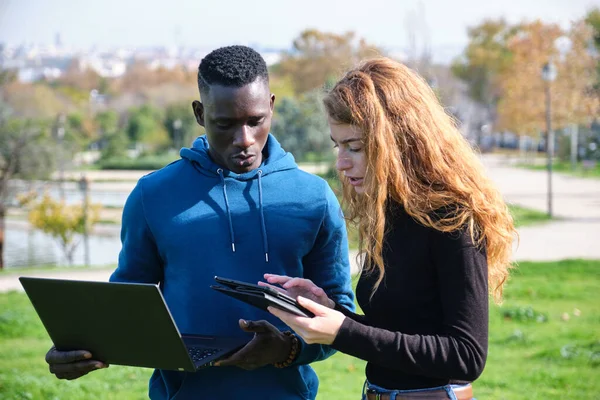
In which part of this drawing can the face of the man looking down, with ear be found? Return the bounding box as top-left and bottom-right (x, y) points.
(192, 78), (275, 174)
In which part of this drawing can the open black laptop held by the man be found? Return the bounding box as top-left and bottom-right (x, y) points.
(19, 277), (251, 372)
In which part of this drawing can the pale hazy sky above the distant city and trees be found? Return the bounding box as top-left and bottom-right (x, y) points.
(0, 0), (600, 62)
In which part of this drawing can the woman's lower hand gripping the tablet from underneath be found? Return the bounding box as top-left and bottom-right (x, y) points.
(268, 296), (346, 344)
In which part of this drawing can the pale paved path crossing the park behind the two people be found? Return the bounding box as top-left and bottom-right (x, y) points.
(0, 155), (600, 292)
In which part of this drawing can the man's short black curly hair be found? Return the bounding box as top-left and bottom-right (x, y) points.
(198, 46), (269, 94)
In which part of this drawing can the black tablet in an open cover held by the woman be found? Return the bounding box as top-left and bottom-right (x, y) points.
(211, 276), (314, 318)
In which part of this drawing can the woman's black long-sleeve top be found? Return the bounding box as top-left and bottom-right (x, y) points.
(332, 207), (488, 389)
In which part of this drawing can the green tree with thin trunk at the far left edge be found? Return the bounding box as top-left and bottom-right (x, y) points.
(0, 107), (55, 269)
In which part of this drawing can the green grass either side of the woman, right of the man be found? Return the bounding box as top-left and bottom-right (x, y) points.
(314, 260), (600, 400)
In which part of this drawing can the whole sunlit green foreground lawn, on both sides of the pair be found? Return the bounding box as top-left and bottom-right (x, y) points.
(0, 260), (600, 400)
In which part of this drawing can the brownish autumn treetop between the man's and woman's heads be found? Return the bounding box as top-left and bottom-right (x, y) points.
(273, 29), (382, 94)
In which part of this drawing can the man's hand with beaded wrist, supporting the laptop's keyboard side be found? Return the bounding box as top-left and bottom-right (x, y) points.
(215, 319), (292, 370)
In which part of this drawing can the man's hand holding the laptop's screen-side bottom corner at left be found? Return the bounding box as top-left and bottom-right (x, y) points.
(46, 346), (108, 380)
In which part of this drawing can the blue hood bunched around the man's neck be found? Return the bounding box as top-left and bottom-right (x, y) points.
(179, 134), (298, 181)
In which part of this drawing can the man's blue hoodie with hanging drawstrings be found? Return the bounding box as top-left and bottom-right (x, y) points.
(111, 135), (354, 400)
